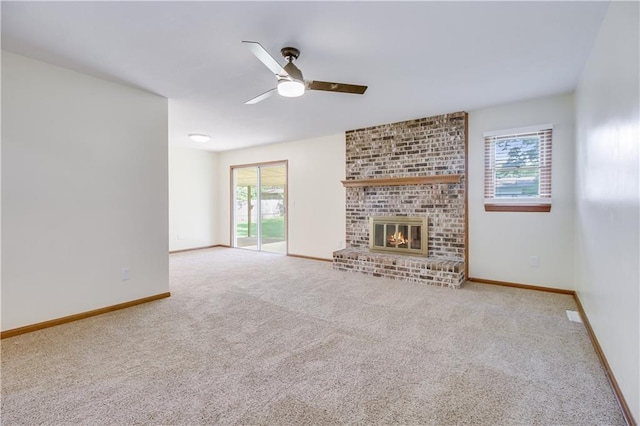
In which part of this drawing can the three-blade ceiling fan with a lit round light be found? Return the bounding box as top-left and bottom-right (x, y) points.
(243, 41), (367, 104)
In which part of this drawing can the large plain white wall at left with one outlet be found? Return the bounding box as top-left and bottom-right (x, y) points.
(2, 52), (169, 330)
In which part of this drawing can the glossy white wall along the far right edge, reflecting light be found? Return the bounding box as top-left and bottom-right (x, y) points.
(576, 2), (640, 421)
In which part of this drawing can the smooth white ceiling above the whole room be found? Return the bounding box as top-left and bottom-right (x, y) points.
(2, 1), (608, 151)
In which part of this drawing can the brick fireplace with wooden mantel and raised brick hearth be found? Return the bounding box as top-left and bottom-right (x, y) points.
(333, 112), (467, 288)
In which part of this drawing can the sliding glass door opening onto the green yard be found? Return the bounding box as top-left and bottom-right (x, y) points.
(231, 162), (287, 254)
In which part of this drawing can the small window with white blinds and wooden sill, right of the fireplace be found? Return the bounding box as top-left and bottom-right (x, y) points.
(484, 124), (553, 212)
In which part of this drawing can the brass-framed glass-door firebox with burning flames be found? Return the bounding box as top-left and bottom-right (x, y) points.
(369, 216), (428, 256)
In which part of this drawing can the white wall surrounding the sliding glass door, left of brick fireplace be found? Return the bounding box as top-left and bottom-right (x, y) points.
(218, 134), (345, 259)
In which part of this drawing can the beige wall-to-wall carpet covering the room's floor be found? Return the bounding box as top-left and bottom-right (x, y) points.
(1, 248), (624, 425)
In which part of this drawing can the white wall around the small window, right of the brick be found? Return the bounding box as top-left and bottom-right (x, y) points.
(468, 94), (575, 289)
